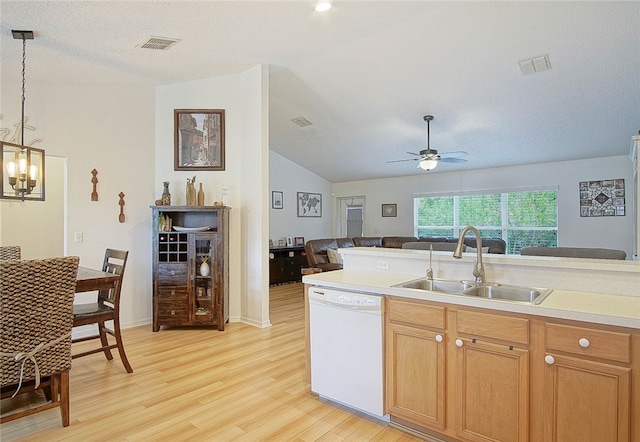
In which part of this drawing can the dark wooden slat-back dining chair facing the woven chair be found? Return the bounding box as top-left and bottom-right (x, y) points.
(72, 249), (133, 373)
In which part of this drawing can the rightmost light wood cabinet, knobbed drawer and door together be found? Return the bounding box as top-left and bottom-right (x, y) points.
(544, 322), (638, 442)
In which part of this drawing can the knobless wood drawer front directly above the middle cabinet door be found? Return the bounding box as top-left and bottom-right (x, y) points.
(457, 310), (529, 345)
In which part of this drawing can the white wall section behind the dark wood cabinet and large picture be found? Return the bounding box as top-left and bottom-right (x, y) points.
(153, 66), (269, 326)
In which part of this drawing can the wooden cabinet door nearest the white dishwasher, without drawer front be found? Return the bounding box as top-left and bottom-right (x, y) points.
(387, 324), (445, 430)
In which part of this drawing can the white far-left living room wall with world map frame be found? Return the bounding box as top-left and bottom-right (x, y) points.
(268, 151), (334, 244)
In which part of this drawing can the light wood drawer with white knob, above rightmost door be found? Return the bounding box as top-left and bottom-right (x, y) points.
(545, 324), (631, 363)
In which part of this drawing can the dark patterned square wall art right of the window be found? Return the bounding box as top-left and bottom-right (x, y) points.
(580, 178), (625, 217)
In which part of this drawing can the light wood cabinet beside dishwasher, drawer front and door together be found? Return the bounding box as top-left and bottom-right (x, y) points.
(386, 299), (446, 430)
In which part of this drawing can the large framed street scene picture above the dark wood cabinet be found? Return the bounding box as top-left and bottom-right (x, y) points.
(173, 109), (224, 170)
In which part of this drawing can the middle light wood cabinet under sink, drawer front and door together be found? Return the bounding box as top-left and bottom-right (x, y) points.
(453, 309), (529, 442)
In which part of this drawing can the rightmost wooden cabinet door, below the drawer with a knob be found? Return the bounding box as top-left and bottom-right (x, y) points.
(544, 354), (631, 442)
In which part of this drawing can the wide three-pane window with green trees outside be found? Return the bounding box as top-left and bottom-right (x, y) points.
(414, 190), (558, 255)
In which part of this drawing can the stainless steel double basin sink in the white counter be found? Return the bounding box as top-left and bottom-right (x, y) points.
(393, 278), (552, 304)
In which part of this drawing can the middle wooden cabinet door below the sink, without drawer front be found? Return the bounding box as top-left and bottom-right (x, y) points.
(455, 338), (528, 442)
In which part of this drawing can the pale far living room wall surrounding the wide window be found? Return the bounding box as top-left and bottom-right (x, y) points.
(333, 156), (634, 258)
